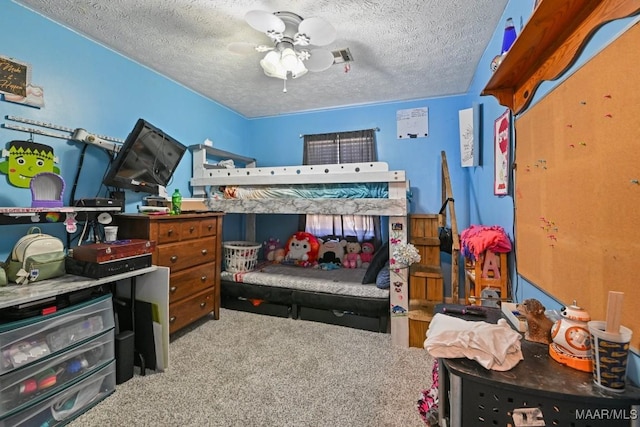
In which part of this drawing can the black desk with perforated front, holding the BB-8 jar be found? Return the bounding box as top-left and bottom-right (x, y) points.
(436, 306), (640, 427)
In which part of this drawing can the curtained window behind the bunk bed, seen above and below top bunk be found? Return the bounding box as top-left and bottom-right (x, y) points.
(303, 129), (380, 242)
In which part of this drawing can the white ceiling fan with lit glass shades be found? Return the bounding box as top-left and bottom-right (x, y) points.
(228, 10), (336, 88)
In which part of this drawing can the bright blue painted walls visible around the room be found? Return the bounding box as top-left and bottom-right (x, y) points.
(0, 0), (640, 382)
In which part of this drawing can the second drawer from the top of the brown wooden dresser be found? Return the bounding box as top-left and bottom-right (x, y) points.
(157, 237), (216, 272)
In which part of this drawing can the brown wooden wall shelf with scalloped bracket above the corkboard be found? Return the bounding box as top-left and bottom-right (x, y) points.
(481, 0), (640, 114)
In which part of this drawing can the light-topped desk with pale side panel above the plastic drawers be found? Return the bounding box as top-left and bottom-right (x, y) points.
(0, 266), (169, 368)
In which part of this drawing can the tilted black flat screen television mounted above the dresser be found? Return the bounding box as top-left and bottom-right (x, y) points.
(103, 119), (187, 194)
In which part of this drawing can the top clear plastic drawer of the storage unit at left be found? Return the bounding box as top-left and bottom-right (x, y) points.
(0, 295), (114, 375)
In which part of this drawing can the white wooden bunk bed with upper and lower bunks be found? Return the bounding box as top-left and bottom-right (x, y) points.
(189, 145), (409, 346)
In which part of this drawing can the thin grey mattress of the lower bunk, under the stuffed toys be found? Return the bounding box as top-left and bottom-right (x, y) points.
(221, 263), (389, 300)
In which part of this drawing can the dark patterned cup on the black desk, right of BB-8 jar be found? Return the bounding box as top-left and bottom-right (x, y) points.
(588, 320), (632, 392)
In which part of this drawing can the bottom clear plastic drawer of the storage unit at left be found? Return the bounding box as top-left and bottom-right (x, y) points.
(0, 360), (116, 427)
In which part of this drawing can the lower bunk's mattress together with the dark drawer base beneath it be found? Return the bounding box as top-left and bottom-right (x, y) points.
(221, 263), (390, 332)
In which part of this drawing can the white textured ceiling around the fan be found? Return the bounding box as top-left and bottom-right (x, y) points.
(14, 0), (507, 118)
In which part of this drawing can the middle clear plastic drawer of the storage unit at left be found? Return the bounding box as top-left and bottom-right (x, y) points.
(0, 329), (115, 418)
